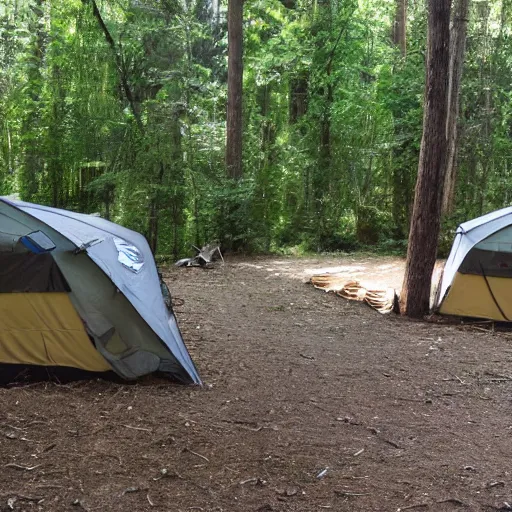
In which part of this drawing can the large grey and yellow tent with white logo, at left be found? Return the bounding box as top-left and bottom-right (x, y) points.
(0, 198), (200, 383)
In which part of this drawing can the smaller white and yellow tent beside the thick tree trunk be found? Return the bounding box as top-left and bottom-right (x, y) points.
(435, 207), (512, 322)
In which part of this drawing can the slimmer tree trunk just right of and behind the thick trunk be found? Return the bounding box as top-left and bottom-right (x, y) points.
(442, 0), (469, 214)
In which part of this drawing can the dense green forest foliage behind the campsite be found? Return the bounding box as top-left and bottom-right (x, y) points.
(0, 0), (512, 257)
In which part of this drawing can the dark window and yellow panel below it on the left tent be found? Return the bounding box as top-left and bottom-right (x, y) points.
(0, 252), (111, 372)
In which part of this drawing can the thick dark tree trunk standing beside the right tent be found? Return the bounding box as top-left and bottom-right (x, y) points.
(400, 0), (450, 317)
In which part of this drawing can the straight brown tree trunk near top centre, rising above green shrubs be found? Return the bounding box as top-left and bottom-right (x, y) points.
(226, 0), (243, 179)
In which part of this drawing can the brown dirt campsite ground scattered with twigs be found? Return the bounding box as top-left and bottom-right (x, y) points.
(0, 253), (512, 512)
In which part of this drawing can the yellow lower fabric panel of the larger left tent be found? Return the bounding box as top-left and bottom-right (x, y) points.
(0, 292), (111, 372)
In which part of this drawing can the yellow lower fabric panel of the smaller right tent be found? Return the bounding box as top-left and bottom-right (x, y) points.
(439, 272), (512, 321)
